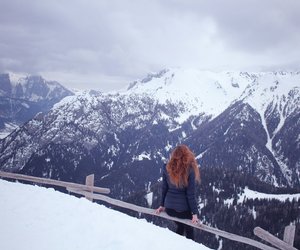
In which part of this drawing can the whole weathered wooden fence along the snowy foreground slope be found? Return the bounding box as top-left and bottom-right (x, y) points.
(0, 171), (297, 250)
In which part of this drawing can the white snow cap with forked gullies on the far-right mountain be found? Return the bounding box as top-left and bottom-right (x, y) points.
(240, 72), (300, 147)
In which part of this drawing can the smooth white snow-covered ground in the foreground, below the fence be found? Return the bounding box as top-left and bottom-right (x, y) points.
(0, 180), (209, 250)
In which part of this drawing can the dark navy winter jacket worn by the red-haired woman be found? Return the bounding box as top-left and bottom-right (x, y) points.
(160, 165), (198, 214)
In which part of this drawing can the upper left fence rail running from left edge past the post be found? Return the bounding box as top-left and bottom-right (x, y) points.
(0, 171), (110, 194)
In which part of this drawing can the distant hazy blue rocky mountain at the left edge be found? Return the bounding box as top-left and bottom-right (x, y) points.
(0, 73), (73, 138)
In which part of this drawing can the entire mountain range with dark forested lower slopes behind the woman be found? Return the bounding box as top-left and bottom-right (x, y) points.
(0, 69), (300, 250)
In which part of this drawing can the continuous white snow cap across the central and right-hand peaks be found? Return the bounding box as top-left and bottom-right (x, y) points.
(123, 68), (300, 116)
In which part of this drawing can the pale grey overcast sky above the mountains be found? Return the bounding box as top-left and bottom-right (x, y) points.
(0, 0), (300, 91)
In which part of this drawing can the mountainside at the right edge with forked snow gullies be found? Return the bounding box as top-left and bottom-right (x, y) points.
(240, 72), (300, 184)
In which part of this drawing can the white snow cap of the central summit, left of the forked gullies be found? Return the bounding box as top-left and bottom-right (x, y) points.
(123, 68), (255, 119)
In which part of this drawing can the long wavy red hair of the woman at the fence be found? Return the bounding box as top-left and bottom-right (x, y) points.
(167, 145), (200, 187)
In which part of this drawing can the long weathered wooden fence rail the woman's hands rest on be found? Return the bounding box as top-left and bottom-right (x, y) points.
(68, 188), (278, 250)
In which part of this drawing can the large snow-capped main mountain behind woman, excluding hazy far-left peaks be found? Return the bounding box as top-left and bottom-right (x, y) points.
(0, 69), (300, 197)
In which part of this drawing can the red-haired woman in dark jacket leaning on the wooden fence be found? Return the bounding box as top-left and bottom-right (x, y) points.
(156, 145), (200, 239)
